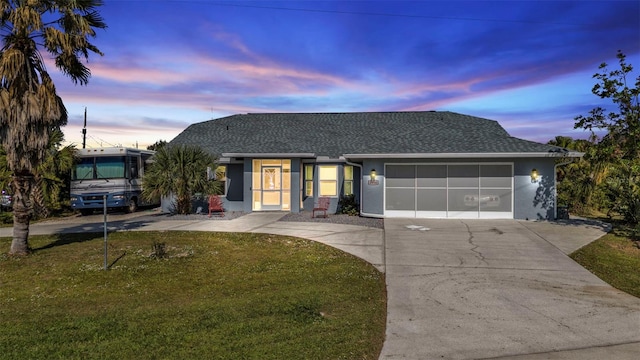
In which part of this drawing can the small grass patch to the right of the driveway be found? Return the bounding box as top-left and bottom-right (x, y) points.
(570, 225), (640, 297)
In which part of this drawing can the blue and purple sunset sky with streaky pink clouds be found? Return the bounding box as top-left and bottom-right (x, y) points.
(50, 0), (640, 147)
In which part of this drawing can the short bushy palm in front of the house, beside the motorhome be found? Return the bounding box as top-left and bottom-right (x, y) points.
(142, 145), (221, 214)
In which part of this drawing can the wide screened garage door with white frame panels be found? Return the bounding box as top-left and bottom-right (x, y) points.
(384, 163), (513, 219)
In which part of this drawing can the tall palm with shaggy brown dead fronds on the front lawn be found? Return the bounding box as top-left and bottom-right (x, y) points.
(0, 0), (106, 255)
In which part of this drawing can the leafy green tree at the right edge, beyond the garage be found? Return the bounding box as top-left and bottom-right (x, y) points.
(575, 51), (640, 223)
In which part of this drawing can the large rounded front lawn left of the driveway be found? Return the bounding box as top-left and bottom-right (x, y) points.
(0, 232), (386, 359)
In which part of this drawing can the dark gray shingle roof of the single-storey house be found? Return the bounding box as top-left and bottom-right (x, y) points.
(170, 111), (563, 158)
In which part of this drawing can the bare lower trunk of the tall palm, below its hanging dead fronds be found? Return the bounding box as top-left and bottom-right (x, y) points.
(9, 175), (33, 255)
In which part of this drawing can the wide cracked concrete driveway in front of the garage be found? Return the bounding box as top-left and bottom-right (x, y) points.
(380, 219), (640, 359)
